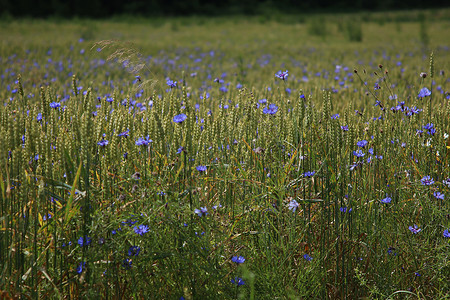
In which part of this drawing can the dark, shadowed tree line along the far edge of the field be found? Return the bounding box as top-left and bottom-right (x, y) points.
(0, 0), (450, 18)
